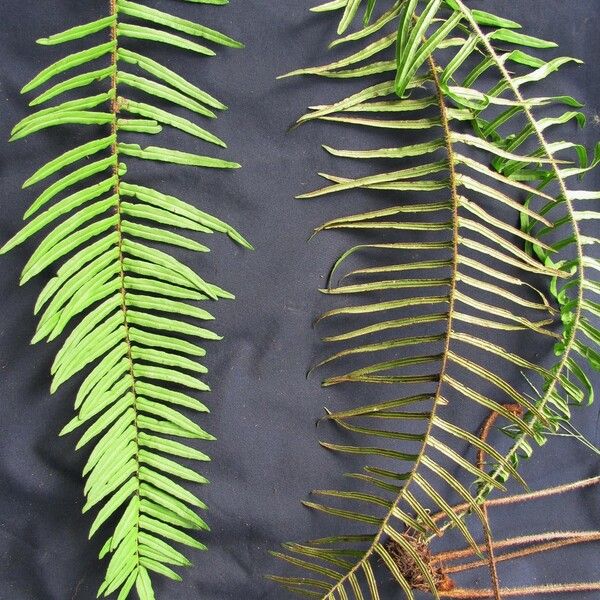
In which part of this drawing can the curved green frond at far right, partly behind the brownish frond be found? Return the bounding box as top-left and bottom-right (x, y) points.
(440, 0), (600, 496)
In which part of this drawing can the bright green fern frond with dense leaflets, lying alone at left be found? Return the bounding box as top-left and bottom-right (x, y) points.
(0, 0), (251, 600)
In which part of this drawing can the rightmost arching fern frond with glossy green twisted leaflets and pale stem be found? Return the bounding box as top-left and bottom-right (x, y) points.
(442, 0), (600, 497)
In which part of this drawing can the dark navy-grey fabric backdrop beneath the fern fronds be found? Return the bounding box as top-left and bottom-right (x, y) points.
(0, 0), (600, 600)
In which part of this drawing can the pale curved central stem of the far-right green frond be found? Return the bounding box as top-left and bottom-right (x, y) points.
(455, 0), (584, 501)
